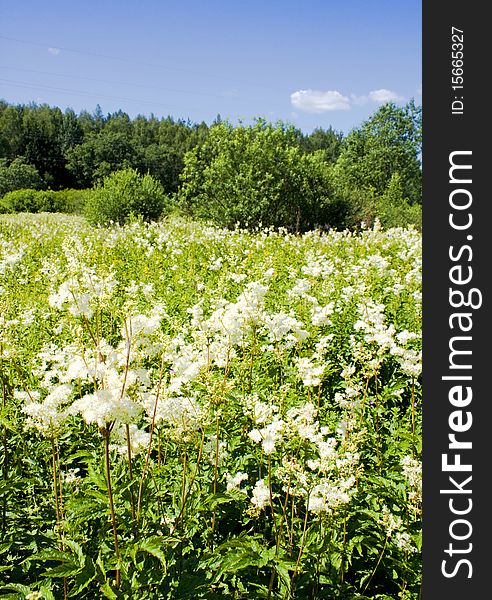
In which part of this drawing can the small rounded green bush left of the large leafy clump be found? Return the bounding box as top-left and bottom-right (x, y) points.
(85, 169), (166, 225)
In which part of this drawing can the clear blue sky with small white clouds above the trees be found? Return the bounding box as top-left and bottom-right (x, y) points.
(0, 0), (422, 133)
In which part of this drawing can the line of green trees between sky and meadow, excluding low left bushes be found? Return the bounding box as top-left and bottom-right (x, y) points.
(0, 101), (422, 230)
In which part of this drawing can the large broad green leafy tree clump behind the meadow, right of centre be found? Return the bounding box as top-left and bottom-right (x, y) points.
(179, 120), (344, 231)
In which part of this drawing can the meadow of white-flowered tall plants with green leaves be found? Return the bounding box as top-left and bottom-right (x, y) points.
(0, 214), (422, 600)
